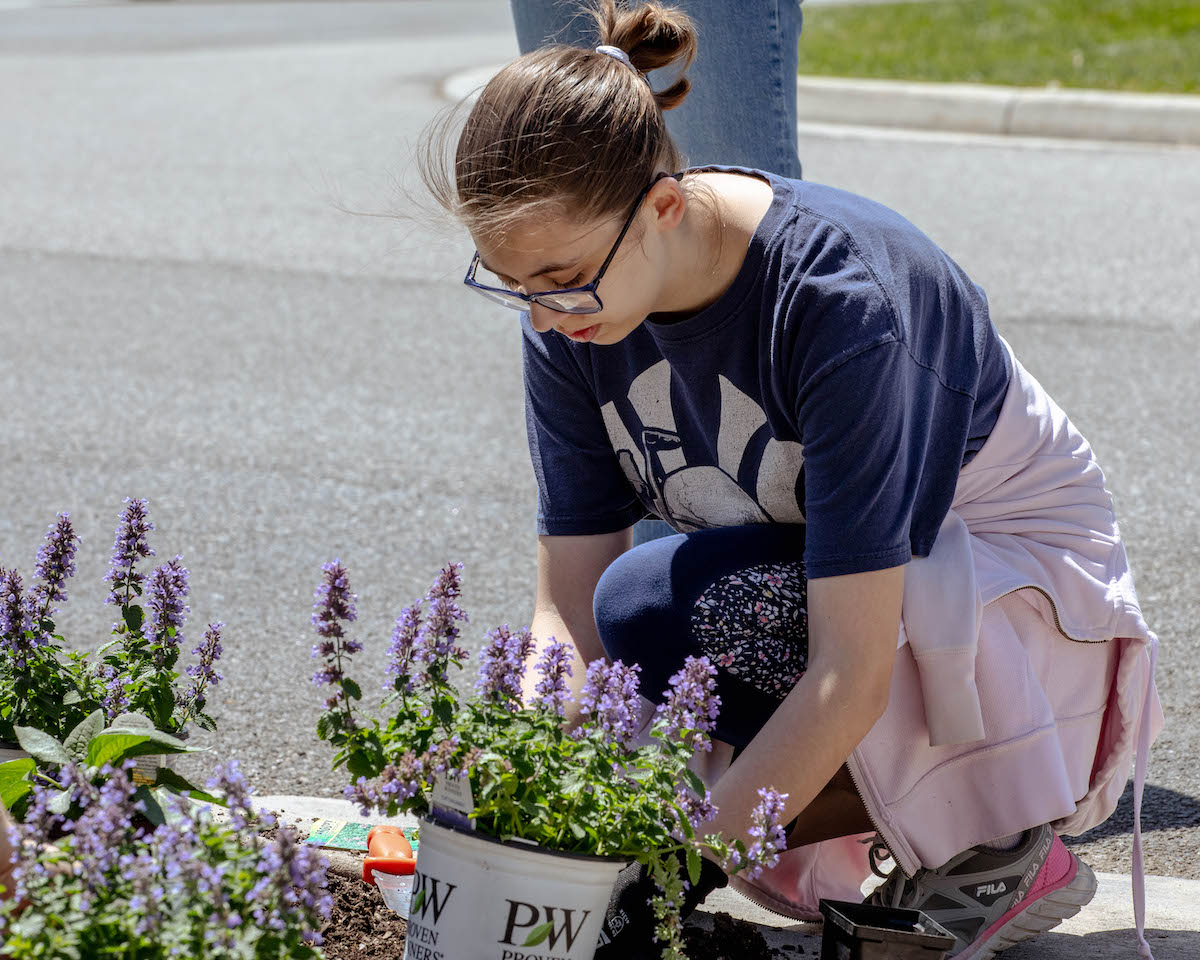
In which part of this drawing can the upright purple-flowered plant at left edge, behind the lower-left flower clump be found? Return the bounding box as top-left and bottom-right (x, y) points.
(0, 499), (224, 740)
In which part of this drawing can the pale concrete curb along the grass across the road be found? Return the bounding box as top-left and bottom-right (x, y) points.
(442, 64), (1200, 146)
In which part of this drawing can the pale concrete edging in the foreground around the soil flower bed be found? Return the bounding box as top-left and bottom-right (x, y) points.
(254, 796), (1200, 960)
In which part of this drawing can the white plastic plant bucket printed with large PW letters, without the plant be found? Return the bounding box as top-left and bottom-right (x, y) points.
(403, 821), (626, 960)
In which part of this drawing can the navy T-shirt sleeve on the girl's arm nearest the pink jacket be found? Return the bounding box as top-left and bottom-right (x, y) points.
(798, 340), (971, 580)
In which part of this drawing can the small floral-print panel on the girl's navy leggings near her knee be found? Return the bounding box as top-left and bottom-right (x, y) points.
(691, 563), (809, 700)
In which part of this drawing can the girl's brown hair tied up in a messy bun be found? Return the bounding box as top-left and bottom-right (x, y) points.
(420, 0), (696, 243)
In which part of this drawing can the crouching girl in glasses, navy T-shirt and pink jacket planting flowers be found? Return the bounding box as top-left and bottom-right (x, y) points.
(426, 2), (1160, 960)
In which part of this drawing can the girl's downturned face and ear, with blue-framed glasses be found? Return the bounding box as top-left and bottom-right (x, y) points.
(475, 179), (685, 346)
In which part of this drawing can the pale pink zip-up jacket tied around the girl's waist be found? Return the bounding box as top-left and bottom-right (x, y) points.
(733, 343), (1163, 956)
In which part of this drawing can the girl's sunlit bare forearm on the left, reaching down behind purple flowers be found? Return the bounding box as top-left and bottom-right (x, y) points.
(521, 528), (634, 724)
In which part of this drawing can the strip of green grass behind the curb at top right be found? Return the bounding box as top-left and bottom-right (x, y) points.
(800, 0), (1200, 94)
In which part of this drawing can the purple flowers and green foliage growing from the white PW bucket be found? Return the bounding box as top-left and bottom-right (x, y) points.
(313, 562), (785, 958)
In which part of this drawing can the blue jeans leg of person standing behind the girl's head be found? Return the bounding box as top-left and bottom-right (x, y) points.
(510, 0), (803, 179)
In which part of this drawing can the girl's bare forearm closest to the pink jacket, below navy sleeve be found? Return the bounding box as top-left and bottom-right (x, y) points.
(702, 566), (904, 846)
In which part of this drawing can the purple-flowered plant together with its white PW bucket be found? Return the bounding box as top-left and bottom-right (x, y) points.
(312, 560), (785, 960)
